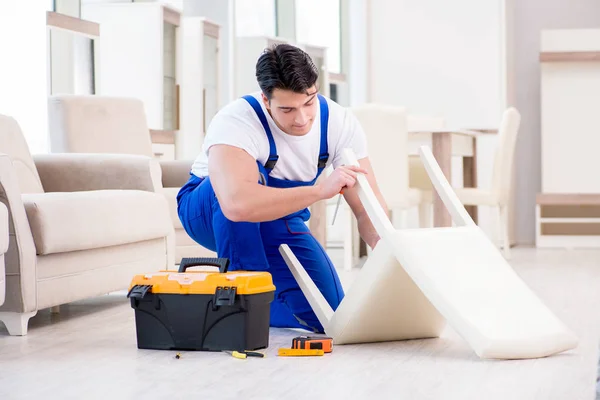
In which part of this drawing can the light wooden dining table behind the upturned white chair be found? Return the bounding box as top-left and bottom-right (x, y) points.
(309, 129), (497, 247)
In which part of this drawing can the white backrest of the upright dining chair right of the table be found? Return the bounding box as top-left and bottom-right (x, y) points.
(492, 107), (521, 202)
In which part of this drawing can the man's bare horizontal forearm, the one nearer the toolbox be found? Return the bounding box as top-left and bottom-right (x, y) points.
(219, 183), (321, 222)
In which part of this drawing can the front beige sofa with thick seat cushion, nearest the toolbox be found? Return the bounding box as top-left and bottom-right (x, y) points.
(0, 115), (174, 335)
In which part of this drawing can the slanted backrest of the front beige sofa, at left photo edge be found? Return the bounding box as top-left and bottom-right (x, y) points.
(0, 115), (44, 194)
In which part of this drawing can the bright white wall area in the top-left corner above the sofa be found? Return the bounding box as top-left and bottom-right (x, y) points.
(0, 1), (48, 153)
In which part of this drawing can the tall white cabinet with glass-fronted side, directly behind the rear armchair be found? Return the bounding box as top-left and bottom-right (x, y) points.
(81, 2), (181, 159)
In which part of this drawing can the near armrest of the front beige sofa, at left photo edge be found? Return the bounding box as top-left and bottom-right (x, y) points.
(0, 154), (37, 313)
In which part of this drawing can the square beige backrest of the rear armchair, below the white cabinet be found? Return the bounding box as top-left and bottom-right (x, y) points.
(48, 95), (152, 157)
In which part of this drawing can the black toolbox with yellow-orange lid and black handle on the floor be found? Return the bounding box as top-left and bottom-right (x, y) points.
(127, 258), (275, 351)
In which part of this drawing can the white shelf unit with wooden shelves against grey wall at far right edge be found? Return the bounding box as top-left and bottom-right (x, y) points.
(536, 29), (600, 248)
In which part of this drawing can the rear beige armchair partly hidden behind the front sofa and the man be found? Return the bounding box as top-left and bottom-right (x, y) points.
(48, 95), (215, 263)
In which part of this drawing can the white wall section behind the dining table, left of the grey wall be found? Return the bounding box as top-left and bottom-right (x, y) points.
(367, 0), (507, 237)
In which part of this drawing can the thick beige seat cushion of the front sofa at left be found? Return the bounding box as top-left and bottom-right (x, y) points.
(23, 190), (173, 255)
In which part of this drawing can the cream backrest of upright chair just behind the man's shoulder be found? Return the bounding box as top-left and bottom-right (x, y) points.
(351, 103), (408, 208)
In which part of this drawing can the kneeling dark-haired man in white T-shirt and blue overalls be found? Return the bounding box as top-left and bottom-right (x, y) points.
(177, 44), (387, 332)
